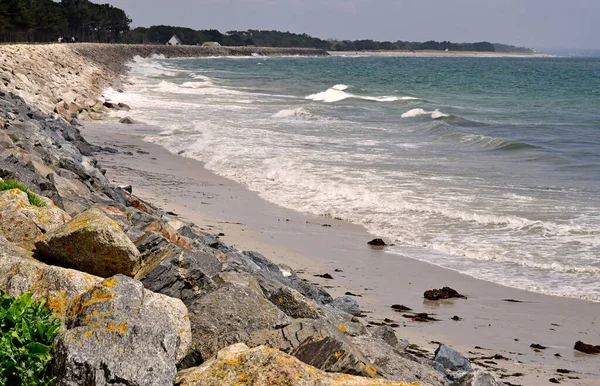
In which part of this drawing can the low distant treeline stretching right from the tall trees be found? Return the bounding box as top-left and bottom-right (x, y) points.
(124, 25), (533, 53)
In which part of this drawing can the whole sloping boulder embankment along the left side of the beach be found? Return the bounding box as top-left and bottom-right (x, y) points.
(0, 45), (500, 386)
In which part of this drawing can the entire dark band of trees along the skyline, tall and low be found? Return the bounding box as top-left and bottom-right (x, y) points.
(0, 0), (533, 53)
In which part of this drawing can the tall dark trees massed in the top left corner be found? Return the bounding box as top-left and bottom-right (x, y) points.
(0, 0), (131, 42)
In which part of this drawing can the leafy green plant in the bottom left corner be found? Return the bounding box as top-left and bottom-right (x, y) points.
(0, 291), (61, 386)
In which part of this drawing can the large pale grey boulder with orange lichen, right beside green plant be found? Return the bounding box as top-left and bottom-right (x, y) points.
(52, 275), (189, 386)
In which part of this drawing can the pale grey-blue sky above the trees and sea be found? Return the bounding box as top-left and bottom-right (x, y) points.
(105, 0), (600, 49)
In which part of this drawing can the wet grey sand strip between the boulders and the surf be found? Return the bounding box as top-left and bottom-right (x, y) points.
(82, 121), (600, 385)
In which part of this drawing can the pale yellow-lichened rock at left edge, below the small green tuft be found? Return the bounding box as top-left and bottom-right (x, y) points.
(0, 189), (71, 250)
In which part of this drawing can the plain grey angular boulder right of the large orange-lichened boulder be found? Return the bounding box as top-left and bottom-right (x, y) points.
(185, 283), (291, 366)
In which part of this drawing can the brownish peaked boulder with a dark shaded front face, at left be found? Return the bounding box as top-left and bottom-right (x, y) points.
(35, 208), (141, 277)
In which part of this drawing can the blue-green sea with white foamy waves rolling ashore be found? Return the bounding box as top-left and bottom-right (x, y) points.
(105, 56), (600, 301)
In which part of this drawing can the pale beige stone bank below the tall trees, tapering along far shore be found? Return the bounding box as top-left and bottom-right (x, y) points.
(0, 43), (327, 120)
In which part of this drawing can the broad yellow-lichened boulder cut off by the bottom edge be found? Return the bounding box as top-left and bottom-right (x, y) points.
(177, 343), (428, 386)
